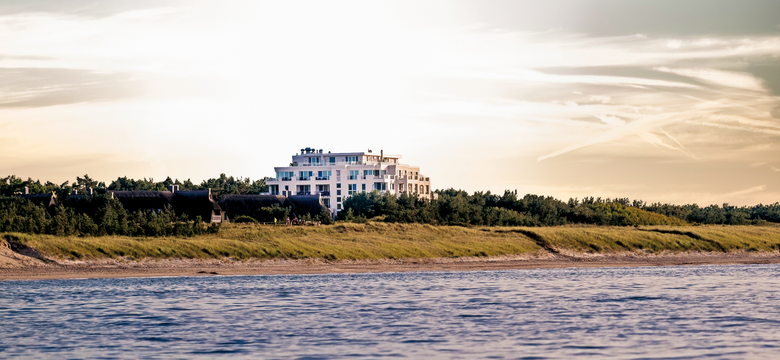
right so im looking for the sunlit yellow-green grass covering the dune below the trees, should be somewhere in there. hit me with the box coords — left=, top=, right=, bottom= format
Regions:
left=0, top=222, right=780, bottom=260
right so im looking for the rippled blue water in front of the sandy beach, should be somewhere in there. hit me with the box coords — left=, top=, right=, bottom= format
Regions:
left=0, top=265, right=780, bottom=359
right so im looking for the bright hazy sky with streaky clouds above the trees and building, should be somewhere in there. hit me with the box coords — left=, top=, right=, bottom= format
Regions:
left=0, top=0, right=780, bottom=205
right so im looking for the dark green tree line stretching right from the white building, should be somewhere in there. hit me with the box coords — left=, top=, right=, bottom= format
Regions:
left=339, top=189, right=780, bottom=226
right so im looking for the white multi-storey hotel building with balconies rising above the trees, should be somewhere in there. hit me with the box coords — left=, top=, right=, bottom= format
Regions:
left=266, top=148, right=431, bottom=215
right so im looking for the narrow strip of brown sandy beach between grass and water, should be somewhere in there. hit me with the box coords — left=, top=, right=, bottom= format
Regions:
left=0, top=251, right=780, bottom=281
